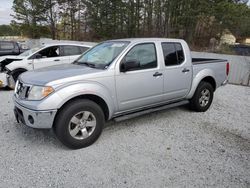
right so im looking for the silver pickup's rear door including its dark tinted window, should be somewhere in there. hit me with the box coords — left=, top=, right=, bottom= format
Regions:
left=161, top=42, right=192, bottom=101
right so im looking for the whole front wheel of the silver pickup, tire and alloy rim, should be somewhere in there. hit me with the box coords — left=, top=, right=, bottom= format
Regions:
left=53, top=99, right=105, bottom=149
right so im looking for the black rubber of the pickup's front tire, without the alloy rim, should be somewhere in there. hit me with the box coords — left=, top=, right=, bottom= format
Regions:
left=54, top=99, right=105, bottom=149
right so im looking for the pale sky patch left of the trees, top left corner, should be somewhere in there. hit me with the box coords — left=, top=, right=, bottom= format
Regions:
left=0, top=0, right=13, bottom=25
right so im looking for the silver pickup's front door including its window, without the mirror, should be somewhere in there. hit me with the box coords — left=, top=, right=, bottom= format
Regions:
left=116, top=43, right=163, bottom=111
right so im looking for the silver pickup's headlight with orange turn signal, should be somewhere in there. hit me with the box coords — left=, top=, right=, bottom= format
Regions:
left=27, top=86, right=54, bottom=100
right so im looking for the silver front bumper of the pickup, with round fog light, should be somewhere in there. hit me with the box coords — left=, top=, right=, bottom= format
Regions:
left=14, top=101, right=57, bottom=129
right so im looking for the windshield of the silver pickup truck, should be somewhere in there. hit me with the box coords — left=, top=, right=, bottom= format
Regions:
left=74, top=41, right=129, bottom=69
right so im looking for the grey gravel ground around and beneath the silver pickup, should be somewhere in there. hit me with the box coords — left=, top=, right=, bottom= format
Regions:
left=0, top=85, right=250, bottom=188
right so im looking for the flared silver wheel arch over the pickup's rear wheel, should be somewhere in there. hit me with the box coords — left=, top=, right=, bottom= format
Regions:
left=187, top=69, right=215, bottom=99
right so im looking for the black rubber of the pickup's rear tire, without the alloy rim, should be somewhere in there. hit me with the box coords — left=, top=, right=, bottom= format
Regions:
left=190, top=81, right=214, bottom=112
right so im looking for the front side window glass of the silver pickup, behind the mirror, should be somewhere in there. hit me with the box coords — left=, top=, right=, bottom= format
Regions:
left=123, top=43, right=157, bottom=70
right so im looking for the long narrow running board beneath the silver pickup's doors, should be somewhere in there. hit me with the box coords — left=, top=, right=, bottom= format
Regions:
left=114, top=100, right=189, bottom=122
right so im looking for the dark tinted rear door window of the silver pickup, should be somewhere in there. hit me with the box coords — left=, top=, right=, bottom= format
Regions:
left=161, top=43, right=185, bottom=66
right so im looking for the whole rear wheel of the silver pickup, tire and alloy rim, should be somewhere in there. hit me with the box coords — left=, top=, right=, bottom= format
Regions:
left=190, top=81, right=214, bottom=112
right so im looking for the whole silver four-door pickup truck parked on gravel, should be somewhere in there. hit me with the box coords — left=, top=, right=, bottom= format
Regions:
left=14, top=38, right=229, bottom=149
